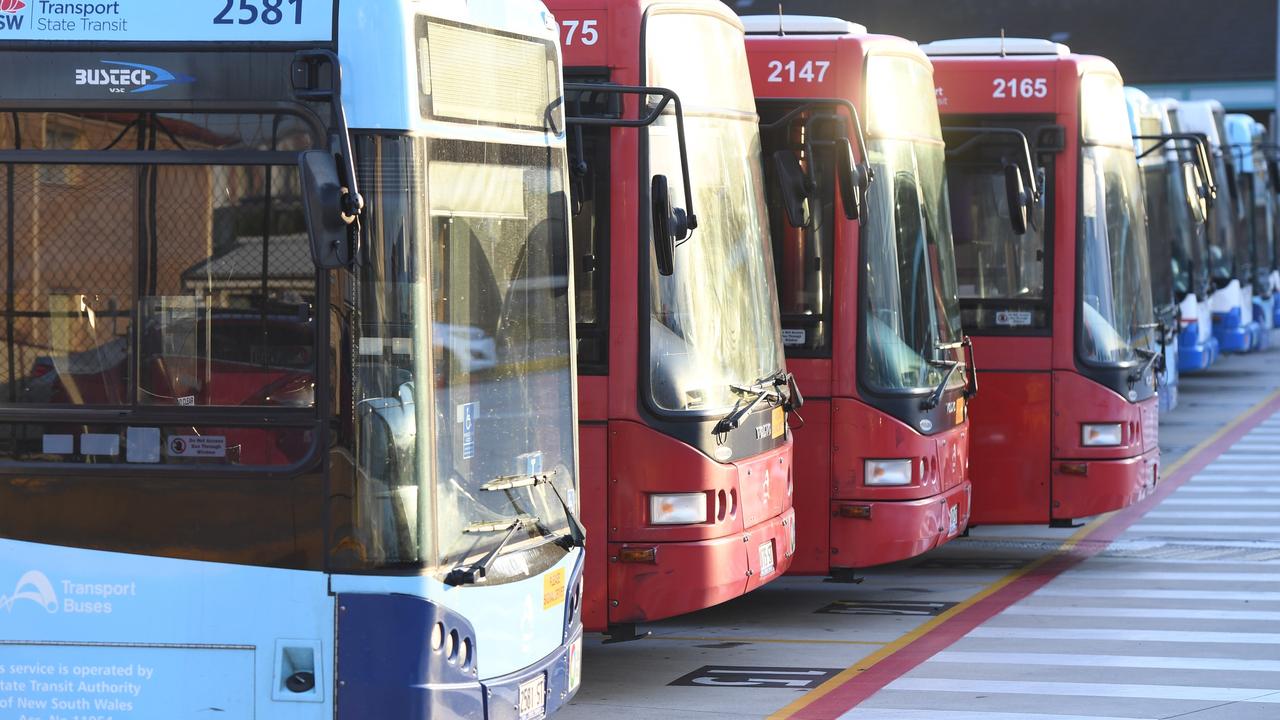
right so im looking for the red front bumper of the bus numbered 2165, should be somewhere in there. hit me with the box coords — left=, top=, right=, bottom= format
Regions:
left=1050, top=450, right=1160, bottom=520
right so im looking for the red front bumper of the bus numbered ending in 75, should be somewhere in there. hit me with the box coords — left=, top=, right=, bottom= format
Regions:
left=609, top=507, right=796, bottom=624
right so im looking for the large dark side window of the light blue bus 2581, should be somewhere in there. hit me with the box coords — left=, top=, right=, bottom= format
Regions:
left=0, top=111, right=317, bottom=450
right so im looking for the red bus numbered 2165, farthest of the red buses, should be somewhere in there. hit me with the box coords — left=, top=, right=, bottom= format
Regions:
left=923, top=38, right=1161, bottom=525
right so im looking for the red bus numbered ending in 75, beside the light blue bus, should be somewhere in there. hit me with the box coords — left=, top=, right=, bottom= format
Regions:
left=548, top=0, right=799, bottom=639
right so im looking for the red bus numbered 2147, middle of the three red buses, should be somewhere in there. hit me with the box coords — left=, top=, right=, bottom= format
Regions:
left=742, top=15, right=973, bottom=578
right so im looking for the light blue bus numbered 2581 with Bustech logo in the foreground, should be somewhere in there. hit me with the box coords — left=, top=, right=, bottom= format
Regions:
left=0, top=0, right=584, bottom=720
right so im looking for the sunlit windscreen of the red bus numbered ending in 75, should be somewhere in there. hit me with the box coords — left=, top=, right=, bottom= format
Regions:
left=643, top=10, right=785, bottom=414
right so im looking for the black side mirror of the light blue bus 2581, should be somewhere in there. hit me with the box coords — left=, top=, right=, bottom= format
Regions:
left=298, top=150, right=357, bottom=270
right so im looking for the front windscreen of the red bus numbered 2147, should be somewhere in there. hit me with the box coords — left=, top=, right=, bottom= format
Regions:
left=859, top=56, right=964, bottom=393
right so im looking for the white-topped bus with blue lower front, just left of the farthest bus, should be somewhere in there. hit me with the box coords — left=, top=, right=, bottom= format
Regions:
left=1178, top=100, right=1262, bottom=352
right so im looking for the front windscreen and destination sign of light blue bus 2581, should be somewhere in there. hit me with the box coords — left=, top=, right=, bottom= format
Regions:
left=334, top=20, right=577, bottom=582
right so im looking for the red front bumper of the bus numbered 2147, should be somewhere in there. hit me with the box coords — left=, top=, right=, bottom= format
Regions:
left=831, top=480, right=973, bottom=569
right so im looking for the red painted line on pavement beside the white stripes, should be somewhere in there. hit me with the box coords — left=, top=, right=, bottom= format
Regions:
left=790, top=395, right=1280, bottom=720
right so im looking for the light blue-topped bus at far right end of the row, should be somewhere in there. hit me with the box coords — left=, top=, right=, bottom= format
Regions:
left=1224, top=113, right=1276, bottom=347
